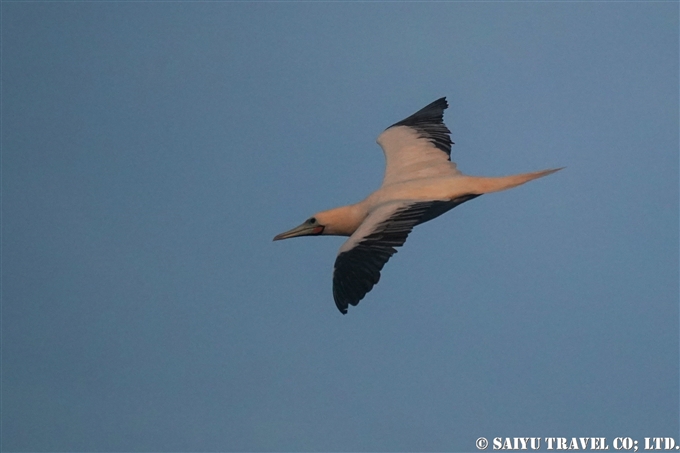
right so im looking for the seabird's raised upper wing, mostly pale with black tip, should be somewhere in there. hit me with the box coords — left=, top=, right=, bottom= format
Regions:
left=378, top=98, right=460, bottom=185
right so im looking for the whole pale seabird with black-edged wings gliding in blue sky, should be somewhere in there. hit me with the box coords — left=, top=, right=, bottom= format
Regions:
left=274, top=97, right=564, bottom=315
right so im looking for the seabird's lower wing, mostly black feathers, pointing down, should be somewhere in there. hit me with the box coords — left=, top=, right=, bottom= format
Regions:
left=333, top=195, right=478, bottom=314
